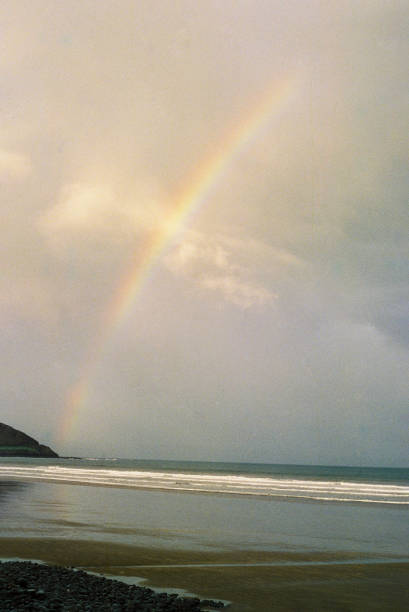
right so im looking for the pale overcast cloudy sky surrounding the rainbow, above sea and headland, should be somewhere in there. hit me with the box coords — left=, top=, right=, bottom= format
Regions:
left=0, top=0, right=409, bottom=465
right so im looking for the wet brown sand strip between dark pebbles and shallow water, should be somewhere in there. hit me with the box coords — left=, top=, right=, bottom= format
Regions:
left=0, top=538, right=409, bottom=612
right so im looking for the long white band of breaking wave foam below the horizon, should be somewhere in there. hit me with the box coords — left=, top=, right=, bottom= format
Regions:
left=0, top=465, right=409, bottom=506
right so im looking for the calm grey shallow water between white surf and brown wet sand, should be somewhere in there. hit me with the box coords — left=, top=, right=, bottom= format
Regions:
left=0, top=481, right=409, bottom=555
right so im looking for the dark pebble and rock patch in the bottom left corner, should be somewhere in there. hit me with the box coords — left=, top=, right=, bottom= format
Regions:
left=0, top=561, right=224, bottom=612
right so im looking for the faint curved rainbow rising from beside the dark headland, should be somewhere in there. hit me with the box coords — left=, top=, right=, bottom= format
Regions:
left=58, top=78, right=297, bottom=443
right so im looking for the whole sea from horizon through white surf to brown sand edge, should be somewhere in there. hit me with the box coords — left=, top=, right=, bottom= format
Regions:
left=0, top=457, right=409, bottom=556
